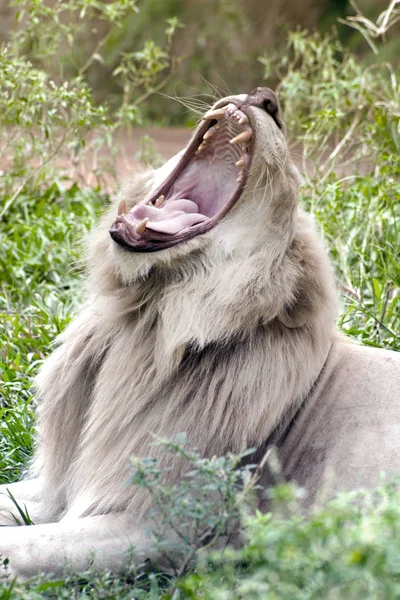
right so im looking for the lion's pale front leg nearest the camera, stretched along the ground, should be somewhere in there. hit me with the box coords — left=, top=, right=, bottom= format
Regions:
left=0, top=512, right=152, bottom=580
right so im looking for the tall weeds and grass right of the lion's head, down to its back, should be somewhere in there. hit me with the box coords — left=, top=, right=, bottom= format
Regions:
left=261, top=31, right=400, bottom=349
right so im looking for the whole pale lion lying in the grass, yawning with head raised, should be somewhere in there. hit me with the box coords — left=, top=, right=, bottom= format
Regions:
left=0, top=88, right=400, bottom=579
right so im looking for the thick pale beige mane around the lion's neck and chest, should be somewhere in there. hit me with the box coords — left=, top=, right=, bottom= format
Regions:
left=34, top=164, right=336, bottom=515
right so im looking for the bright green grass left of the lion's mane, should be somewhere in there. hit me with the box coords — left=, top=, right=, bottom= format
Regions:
left=0, top=185, right=106, bottom=483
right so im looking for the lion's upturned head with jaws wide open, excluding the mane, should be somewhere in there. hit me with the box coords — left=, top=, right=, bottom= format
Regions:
left=104, top=88, right=299, bottom=278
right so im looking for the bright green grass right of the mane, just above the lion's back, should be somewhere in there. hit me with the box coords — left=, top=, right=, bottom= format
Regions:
left=306, top=176, right=400, bottom=350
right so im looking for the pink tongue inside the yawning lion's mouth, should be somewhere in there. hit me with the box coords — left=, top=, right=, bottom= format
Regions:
left=130, top=198, right=207, bottom=235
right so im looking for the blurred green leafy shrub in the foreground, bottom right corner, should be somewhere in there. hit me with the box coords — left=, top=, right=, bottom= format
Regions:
left=177, top=482, right=400, bottom=600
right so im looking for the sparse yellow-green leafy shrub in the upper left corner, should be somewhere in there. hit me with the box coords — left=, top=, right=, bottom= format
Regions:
left=0, top=0, right=181, bottom=220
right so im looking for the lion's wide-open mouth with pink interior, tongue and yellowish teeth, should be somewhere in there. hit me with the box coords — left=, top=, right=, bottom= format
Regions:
left=110, top=102, right=254, bottom=252
